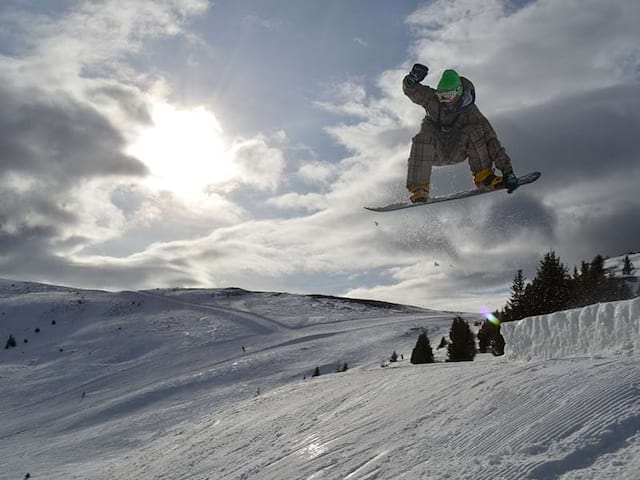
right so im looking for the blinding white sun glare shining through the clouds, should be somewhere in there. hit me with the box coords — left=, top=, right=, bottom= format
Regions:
left=128, top=103, right=235, bottom=198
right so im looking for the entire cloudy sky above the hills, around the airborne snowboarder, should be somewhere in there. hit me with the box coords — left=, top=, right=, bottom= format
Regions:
left=0, top=0, right=640, bottom=311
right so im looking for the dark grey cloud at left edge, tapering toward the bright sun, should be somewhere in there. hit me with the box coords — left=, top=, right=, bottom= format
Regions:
left=0, top=83, right=147, bottom=183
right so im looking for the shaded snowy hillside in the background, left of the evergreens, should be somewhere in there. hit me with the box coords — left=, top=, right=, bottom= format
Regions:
left=0, top=280, right=458, bottom=479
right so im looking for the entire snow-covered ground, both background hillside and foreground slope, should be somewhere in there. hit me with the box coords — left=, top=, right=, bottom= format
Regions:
left=0, top=280, right=640, bottom=480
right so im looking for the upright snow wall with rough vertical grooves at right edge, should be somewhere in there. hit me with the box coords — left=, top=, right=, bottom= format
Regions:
left=502, top=298, right=640, bottom=360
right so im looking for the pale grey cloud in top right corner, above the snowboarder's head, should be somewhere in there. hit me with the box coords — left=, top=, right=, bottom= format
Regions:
left=407, top=0, right=640, bottom=112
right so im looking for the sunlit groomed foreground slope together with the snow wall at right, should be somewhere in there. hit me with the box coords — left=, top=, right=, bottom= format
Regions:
left=102, top=300, right=640, bottom=480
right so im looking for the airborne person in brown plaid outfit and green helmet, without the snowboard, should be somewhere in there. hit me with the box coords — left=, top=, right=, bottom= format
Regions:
left=402, top=63, right=519, bottom=203
